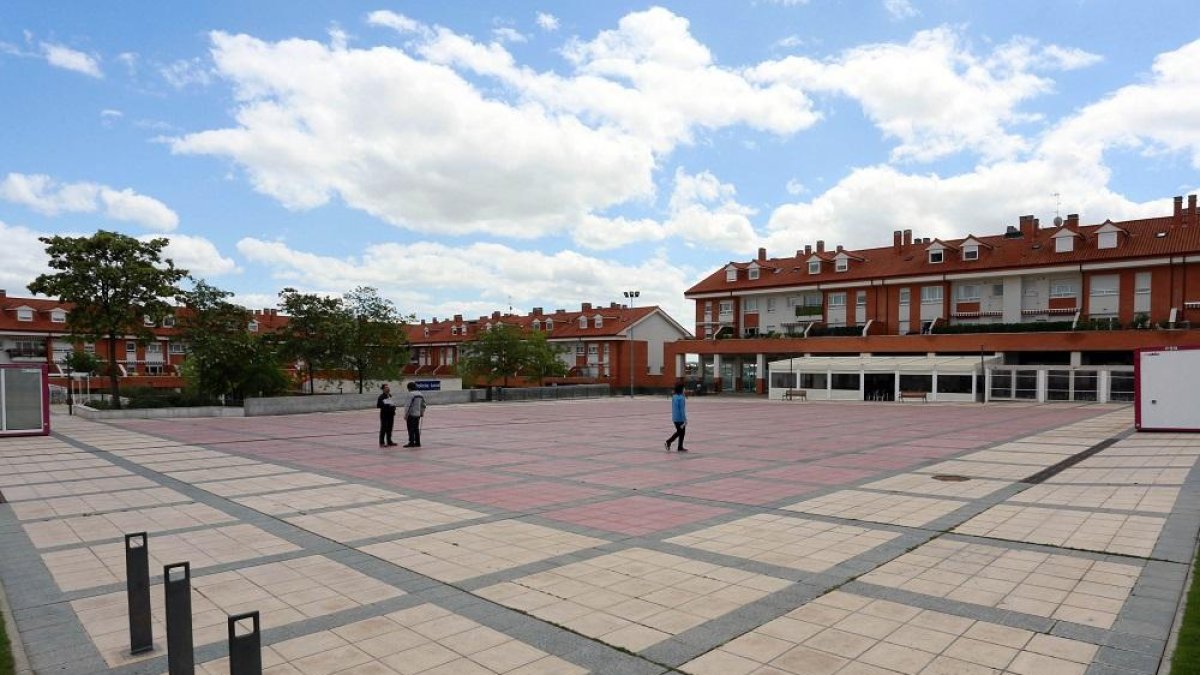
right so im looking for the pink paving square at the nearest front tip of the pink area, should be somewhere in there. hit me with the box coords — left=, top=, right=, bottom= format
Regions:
left=541, top=496, right=730, bottom=536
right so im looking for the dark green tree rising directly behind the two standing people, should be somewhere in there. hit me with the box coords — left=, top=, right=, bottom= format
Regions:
left=342, top=286, right=413, bottom=394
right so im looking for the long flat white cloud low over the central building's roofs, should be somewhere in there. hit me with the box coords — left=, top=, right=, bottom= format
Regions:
left=238, top=238, right=697, bottom=324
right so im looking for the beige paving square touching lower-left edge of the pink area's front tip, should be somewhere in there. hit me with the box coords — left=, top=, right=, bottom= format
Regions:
left=352, top=520, right=605, bottom=581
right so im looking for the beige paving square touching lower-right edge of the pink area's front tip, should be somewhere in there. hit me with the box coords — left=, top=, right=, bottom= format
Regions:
left=667, top=513, right=900, bottom=572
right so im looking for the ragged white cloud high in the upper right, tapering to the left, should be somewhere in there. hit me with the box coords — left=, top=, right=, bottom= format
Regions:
left=752, top=26, right=1087, bottom=162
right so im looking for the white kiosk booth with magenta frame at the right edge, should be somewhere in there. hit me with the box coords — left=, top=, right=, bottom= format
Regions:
left=1133, top=346, right=1200, bottom=431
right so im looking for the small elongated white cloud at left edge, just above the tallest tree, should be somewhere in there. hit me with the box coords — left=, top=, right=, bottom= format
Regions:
left=0, top=173, right=179, bottom=231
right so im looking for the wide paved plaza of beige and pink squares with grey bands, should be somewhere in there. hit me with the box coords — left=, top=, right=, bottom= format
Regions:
left=0, top=396, right=1200, bottom=675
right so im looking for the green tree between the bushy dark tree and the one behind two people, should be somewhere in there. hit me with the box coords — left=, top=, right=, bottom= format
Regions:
left=278, top=288, right=353, bottom=394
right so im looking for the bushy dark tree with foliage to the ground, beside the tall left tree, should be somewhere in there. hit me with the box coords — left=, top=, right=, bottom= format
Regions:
left=179, top=280, right=288, bottom=399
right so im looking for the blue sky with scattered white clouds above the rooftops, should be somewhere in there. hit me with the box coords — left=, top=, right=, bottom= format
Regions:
left=0, top=0, right=1200, bottom=325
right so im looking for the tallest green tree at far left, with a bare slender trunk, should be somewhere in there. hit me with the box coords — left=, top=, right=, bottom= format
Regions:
left=29, top=229, right=187, bottom=408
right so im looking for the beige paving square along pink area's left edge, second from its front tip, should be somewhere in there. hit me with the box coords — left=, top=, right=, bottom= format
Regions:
left=284, top=500, right=486, bottom=544
